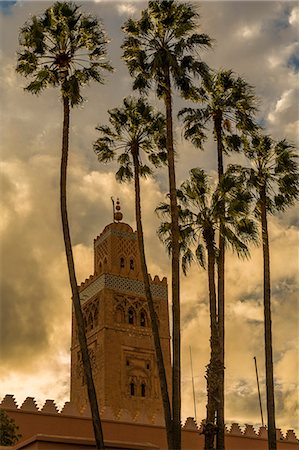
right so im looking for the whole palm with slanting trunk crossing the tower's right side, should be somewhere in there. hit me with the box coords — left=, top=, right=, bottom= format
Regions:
left=94, top=98, right=172, bottom=449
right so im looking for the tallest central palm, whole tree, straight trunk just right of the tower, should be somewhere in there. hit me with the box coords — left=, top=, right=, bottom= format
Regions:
left=122, top=0, right=211, bottom=450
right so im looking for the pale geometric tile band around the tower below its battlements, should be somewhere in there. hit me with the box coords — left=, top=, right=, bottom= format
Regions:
left=80, top=274, right=167, bottom=304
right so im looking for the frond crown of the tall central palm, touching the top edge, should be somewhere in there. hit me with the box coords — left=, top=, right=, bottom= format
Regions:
left=122, top=0, right=211, bottom=98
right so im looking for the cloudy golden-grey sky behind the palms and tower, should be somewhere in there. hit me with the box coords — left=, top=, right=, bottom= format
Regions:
left=0, top=1, right=299, bottom=432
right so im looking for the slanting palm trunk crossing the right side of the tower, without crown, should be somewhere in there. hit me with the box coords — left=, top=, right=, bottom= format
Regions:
left=132, top=149, right=174, bottom=450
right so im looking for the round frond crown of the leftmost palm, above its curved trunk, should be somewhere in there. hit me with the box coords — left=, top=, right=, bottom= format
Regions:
left=17, top=2, right=112, bottom=105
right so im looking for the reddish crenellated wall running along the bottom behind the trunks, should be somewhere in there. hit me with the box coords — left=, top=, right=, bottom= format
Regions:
left=0, top=395, right=299, bottom=450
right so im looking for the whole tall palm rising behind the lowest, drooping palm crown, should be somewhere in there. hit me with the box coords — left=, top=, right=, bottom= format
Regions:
left=179, top=70, right=256, bottom=450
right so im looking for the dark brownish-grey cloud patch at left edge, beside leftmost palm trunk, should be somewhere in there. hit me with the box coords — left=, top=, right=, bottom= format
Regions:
left=0, top=224, right=51, bottom=369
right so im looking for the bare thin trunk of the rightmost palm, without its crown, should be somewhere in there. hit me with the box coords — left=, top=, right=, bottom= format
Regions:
left=260, top=186, right=277, bottom=450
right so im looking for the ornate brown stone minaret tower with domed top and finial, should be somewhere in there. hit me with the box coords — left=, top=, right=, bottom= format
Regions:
left=71, top=202, right=171, bottom=421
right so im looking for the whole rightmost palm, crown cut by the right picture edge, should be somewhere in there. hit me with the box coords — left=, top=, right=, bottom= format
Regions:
left=231, top=135, right=299, bottom=450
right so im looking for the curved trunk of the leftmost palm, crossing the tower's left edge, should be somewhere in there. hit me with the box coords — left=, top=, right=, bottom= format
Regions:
left=60, top=96, right=105, bottom=450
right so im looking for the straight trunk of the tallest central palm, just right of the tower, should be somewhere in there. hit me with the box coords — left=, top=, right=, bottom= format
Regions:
left=164, top=68, right=181, bottom=450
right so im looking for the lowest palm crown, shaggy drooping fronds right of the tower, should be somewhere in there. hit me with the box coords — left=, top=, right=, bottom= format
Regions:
left=157, top=168, right=257, bottom=273
